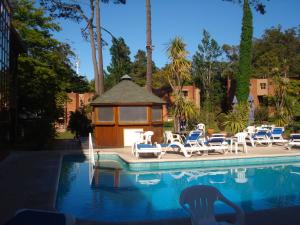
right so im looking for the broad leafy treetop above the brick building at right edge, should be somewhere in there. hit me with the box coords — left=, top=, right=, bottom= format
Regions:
left=253, top=27, right=300, bottom=78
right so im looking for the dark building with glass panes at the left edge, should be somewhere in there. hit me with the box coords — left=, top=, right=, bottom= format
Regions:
left=0, top=0, right=26, bottom=142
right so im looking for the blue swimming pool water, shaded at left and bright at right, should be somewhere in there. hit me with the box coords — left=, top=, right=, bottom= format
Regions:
left=56, top=156, right=300, bottom=222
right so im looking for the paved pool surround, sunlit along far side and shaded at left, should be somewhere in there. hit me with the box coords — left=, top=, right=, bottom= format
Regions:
left=0, top=141, right=300, bottom=225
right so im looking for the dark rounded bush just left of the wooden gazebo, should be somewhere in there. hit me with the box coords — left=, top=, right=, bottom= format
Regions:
left=68, top=107, right=92, bottom=138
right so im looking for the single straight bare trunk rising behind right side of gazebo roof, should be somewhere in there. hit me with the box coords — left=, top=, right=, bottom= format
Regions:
left=146, top=0, right=152, bottom=92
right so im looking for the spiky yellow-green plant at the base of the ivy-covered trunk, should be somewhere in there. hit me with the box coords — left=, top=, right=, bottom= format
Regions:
left=218, top=103, right=249, bottom=134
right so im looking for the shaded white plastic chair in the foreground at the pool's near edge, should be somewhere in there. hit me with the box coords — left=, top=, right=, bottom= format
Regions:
left=179, top=185, right=244, bottom=225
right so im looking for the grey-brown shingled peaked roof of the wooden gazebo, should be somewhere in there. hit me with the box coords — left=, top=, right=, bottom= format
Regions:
left=91, top=75, right=165, bottom=105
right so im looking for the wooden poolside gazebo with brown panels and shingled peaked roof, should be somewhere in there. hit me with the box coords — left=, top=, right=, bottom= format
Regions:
left=91, top=75, right=165, bottom=147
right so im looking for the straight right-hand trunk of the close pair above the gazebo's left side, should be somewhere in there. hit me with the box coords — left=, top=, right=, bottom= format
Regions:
left=96, top=0, right=104, bottom=95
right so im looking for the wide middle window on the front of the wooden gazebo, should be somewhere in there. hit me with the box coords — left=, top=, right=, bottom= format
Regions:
left=119, top=106, right=148, bottom=123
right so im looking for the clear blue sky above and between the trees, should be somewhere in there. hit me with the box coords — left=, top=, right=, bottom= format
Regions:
left=54, top=0, right=300, bottom=80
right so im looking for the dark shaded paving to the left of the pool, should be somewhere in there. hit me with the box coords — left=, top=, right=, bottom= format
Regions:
left=0, top=152, right=61, bottom=224
